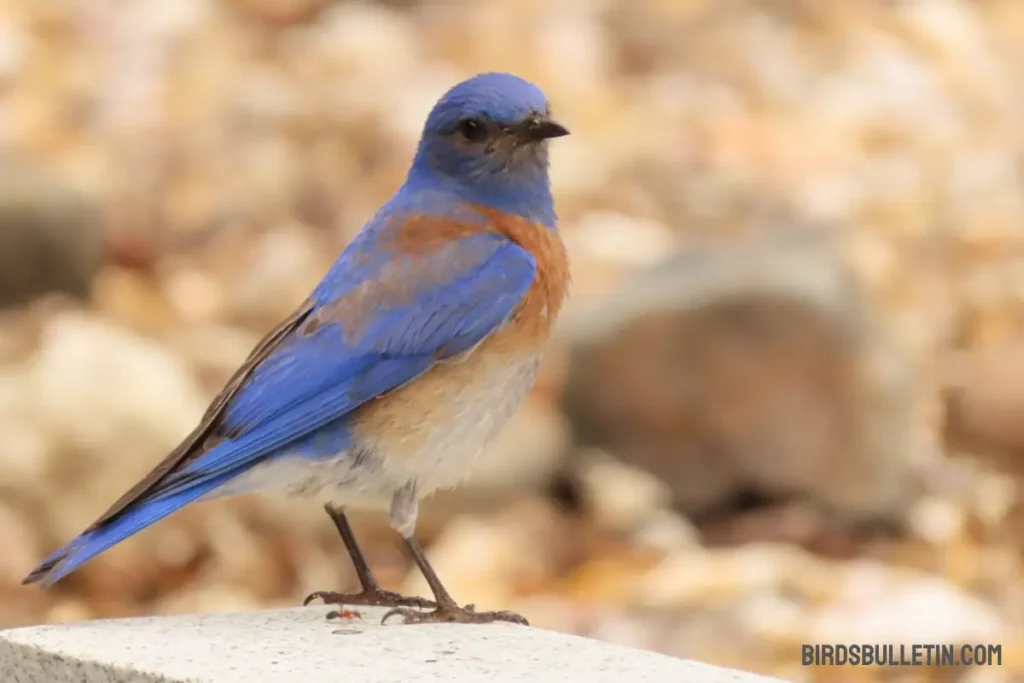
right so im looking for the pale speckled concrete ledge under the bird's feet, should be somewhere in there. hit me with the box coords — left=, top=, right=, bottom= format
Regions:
left=0, top=606, right=774, bottom=683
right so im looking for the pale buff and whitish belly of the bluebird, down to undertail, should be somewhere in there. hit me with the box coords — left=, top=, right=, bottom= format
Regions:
left=209, top=354, right=539, bottom=509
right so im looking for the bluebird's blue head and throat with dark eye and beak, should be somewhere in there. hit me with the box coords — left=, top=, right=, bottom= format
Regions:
left=410, top=73, right=568, bottom=227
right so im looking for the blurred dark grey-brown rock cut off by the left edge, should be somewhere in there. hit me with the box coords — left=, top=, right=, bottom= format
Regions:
left=0, top=159, right=102, bottom=306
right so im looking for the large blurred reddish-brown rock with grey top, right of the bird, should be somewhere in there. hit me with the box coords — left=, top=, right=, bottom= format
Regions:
left=566, top=231, right=914, bottom=519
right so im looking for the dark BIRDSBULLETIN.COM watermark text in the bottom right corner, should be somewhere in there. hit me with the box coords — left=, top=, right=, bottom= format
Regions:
left=800, top=644, right=1002, bottom=667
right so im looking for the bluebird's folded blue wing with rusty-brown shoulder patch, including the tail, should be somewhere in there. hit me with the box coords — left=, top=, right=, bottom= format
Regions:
left=24, top=227, right=537, bottom=585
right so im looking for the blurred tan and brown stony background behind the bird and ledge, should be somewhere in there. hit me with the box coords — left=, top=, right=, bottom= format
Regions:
left=0, top=0, right=1024, bottom=681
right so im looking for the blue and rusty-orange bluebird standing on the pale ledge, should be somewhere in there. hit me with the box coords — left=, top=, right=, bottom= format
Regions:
left=23, top=72, right=570, bottom=624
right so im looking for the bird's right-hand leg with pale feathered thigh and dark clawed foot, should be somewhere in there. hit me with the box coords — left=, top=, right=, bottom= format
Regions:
left=381, top=486, right=528, bottom=626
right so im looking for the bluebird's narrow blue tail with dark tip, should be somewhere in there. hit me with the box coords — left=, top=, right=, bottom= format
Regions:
left=22, top=470, right=238, bottom=586
